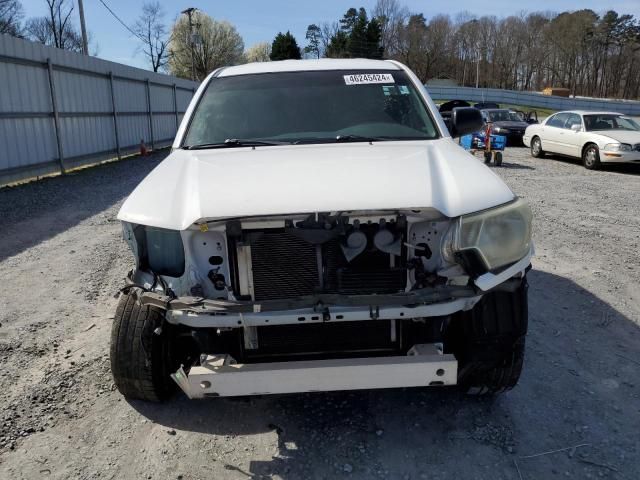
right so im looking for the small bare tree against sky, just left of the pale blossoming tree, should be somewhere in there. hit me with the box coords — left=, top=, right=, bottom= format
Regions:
left=133, top=1, right=169, bottom=72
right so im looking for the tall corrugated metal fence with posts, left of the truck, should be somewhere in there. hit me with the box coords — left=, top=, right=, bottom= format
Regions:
left=0, top=35, right=198, bottom=185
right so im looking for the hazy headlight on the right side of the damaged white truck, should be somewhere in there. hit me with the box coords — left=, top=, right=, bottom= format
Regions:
left=443, top=199, right=532, bottom=270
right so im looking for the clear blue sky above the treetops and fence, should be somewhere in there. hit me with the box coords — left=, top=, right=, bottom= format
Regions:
left=21, top=0, right=640, bottom=68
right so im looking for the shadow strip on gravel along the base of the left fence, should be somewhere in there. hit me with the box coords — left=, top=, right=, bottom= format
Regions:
left=0, top=150, right=168, bottom=260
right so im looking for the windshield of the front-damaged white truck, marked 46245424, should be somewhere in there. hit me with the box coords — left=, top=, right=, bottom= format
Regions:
left=183, top=70, right=438, bottom=148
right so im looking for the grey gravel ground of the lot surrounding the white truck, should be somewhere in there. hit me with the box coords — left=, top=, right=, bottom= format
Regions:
left=0, top=148, right=640, bottom=480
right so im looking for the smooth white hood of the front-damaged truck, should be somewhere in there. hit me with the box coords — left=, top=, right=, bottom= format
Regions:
left=118, top=138, right=514, bottom=230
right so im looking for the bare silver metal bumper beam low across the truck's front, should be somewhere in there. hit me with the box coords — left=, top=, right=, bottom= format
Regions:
left=171, top=344, right=458, bottom=399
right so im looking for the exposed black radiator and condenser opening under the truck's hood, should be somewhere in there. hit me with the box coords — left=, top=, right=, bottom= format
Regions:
left=222, top=214, right=449, bottom=301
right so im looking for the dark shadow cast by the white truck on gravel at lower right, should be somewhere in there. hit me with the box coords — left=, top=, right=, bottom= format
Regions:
left=131, top=271, right=640, bottom=480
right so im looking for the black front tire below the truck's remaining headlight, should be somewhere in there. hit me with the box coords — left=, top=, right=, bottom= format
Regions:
left=452, top=279, right=528, bottom=395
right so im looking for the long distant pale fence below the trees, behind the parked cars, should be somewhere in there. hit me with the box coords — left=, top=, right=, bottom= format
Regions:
left=427, top=85, right=640, bottom=115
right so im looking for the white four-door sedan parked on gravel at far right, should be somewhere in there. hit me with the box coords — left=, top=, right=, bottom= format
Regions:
left=522, top=110, right=640, bottom=169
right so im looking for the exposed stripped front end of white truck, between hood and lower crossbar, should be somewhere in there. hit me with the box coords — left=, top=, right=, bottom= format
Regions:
left=124, top=210, right=478, bottom=327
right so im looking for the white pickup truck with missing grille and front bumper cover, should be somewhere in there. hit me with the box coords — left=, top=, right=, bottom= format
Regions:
left=111, top=59, right=533, bottom=401
